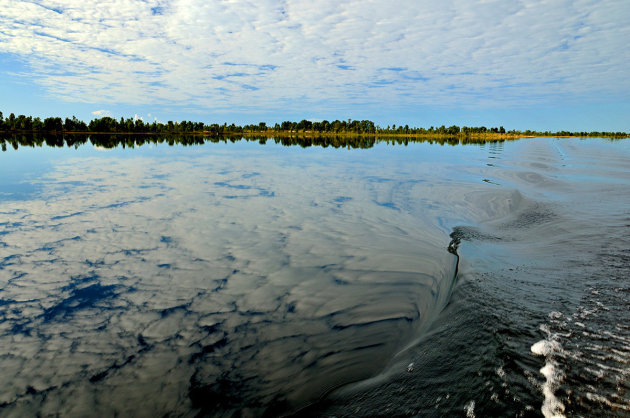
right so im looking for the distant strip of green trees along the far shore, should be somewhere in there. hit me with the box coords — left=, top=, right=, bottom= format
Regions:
left=0, top=112, right=629, bottom=138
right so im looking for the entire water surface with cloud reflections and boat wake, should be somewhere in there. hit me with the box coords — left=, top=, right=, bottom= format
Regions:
left=0, top=138, right=630, bottom=417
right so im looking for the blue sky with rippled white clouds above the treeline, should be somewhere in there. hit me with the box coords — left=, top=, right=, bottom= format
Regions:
left=0, top=0, right=630, bottom=131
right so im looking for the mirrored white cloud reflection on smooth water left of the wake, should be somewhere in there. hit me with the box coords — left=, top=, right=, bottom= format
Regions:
left=0, top=145, right=462, bottom=416
